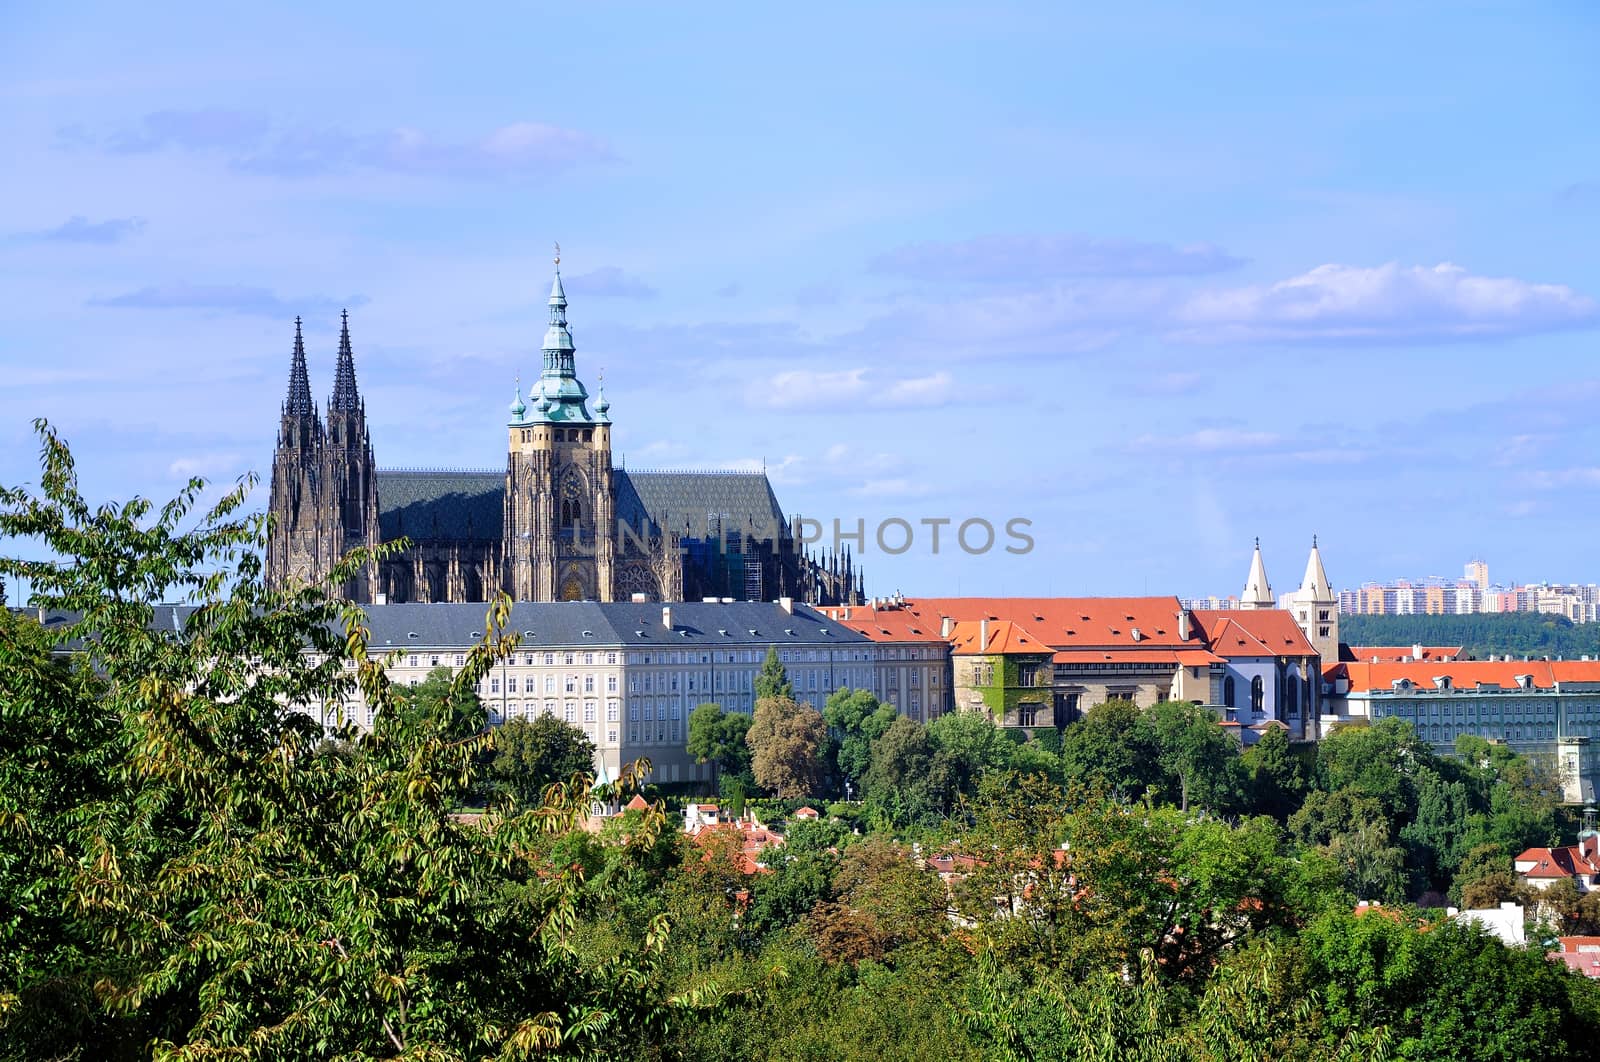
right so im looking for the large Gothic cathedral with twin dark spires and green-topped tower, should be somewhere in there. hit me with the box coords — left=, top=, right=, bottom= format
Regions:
left=267, top=258, right=864, bottom=605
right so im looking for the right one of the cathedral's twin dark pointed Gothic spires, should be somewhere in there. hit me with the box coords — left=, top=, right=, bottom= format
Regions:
left=318, top=310, right=378, bottom=601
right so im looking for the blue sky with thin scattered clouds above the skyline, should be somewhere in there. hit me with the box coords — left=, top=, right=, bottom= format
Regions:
left=0, top=0, right=1600, bottom=597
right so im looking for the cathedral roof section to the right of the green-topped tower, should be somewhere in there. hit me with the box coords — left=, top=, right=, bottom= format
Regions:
left=616, top=469, right=786, bottom=539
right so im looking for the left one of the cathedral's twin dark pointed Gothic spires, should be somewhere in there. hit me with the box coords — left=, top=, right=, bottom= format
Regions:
left=267, top=317, right=325, bottom=587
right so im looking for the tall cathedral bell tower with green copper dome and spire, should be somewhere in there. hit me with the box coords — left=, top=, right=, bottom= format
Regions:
left=502, top=246, right=616, bottom=601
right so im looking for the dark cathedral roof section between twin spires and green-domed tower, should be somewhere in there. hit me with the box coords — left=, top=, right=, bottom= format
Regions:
left=378, top=472, right=506, bottom=542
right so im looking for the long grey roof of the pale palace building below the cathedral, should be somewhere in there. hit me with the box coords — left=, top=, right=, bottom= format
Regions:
left=362, top=601, right=870, bottom=649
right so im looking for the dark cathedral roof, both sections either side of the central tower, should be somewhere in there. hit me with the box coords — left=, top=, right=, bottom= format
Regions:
left=378, top=469, right=787, bottom=541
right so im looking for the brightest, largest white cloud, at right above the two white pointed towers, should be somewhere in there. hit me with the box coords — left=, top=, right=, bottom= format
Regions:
left=1173, top=262, right=1597, bottom=342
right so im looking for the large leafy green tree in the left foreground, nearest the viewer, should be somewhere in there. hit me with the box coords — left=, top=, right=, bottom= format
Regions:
left=0, top=424, right=717, bottom=1057
